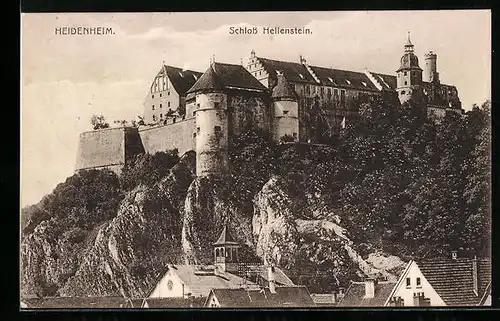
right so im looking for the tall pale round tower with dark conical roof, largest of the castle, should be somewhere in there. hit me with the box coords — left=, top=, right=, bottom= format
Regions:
left=188, top=61, right=228, bottom=176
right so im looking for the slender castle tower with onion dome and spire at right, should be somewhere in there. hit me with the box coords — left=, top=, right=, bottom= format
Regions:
left=396, top=32, right=422, bottom=103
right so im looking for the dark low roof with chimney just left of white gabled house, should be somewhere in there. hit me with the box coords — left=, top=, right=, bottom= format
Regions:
left=338, top=282, right=396, bottom=307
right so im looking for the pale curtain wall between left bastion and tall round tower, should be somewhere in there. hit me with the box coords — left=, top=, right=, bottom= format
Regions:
left=139, top=118, right=196, bottom=155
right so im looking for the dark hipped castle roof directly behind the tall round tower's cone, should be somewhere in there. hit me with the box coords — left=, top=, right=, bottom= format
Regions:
left=187, top=62, right=267, bottom=93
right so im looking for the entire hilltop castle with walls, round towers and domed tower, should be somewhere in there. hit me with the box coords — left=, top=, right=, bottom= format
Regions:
left=76, top=34, right=463, bottom=176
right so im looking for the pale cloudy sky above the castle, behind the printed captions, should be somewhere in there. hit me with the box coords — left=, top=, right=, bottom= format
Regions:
left=21, top=10, right=491, bottom=206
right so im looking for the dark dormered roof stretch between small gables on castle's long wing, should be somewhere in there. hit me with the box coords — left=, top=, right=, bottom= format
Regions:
left=309, top=66, right=378, bottom=91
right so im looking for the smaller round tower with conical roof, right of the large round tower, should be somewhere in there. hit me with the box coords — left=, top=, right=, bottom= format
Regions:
left=271, top=72, right=299, bottom=143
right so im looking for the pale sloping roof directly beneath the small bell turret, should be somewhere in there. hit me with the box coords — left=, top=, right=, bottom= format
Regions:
left=171, top=265, right=258, bottom=297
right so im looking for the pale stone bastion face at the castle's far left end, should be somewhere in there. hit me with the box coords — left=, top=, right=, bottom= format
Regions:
left=75, top=127, right=132, bottom=170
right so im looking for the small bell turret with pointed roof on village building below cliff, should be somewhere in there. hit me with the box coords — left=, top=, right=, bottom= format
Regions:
left=213, top=222, right=240, bottom=273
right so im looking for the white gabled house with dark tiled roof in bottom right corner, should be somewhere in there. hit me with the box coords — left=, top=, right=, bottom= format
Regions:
left=386, top=253, right=491, bottom=306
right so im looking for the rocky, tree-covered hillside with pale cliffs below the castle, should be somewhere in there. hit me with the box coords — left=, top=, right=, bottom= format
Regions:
left=21, top=98, right=491, bottom=297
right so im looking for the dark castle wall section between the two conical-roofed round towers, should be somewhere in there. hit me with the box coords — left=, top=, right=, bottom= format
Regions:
left=228, top=94, right=271, bottom=135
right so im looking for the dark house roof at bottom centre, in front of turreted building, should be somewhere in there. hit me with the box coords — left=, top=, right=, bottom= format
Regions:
left=211, top=286, right=315, bottom=308
